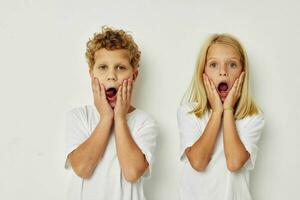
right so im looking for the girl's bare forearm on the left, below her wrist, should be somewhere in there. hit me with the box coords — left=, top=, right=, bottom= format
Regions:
left=186, top=112, right=222, bottom=171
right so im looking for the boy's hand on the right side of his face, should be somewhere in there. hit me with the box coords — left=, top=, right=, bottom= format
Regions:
left=114, top=78, right=133, bottom=119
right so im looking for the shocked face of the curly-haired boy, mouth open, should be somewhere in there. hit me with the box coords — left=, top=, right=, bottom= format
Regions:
left=90, top=48, right=138, bottom=108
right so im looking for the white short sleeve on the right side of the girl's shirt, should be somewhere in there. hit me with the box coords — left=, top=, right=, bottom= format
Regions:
left=238, top=114, right=265, bottom=170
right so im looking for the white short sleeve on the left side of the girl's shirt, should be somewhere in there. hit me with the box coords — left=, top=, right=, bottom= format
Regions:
left=177, top=105, right=203, bottom=161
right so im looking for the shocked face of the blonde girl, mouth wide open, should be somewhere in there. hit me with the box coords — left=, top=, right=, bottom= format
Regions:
left=204, top=44, right=243, bottom=102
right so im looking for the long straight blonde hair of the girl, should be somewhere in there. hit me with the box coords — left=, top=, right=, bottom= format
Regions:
left=182, top=34, right=261, bottom=119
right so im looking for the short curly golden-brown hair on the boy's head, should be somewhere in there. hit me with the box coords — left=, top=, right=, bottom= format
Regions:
left=85, top=26, right=141, bottom=70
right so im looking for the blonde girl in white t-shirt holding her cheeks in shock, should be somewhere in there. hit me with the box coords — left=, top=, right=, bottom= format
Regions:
left=177, top=34, right=264, bottom=200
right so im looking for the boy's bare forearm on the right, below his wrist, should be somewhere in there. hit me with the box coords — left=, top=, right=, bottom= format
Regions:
left=115, top=118, right=148, bottom=182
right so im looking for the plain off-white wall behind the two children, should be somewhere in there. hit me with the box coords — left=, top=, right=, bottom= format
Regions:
left=0, top=0, right=300, bottom=200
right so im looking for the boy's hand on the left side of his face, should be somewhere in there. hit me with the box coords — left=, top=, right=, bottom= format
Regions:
left=92, top=76, right=114, bottom=119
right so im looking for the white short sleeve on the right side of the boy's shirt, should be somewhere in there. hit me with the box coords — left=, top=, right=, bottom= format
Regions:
left=133, top=119, right=158, bottom=178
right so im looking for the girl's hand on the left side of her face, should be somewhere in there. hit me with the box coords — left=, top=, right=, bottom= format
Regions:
left=203, top=74, right=223, bottom=113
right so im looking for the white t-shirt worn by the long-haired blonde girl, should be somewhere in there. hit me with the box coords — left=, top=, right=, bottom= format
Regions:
left=177, top=103, right=264, bottom=200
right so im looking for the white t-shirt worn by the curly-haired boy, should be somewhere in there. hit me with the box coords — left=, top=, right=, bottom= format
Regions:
left=65, top=105, right=158, bottom=200
